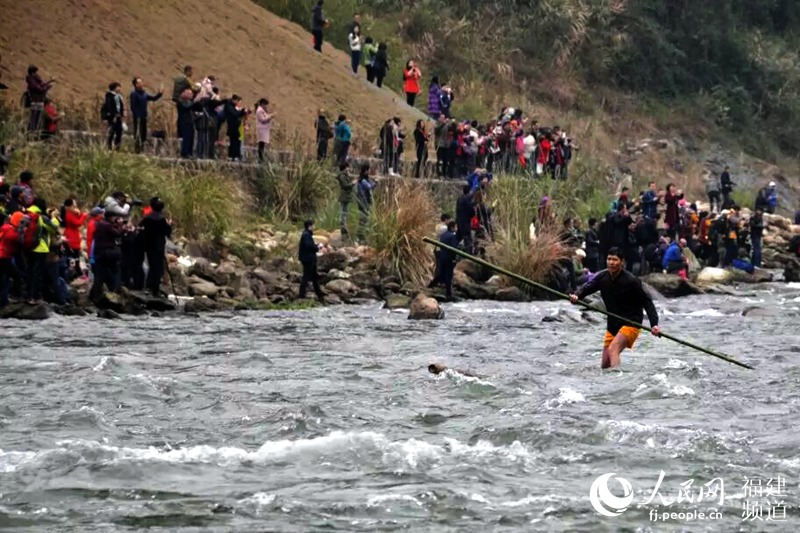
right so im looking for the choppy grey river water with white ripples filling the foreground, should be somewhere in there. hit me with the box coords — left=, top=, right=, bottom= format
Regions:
left=0, top=285, right=800, bottom=532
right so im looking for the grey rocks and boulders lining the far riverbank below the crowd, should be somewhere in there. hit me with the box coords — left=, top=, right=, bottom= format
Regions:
left=0, top=215, right=800, bottom=320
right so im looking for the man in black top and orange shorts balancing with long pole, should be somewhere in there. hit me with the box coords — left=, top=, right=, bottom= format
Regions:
left=570, top=247, right=661, bottom=368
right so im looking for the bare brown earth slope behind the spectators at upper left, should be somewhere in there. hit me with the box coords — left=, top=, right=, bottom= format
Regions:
left=0, top=0, right=419, bottom=144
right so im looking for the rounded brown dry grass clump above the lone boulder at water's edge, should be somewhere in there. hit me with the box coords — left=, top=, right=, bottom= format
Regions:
left=369, top=180, right=438, bottom=286
